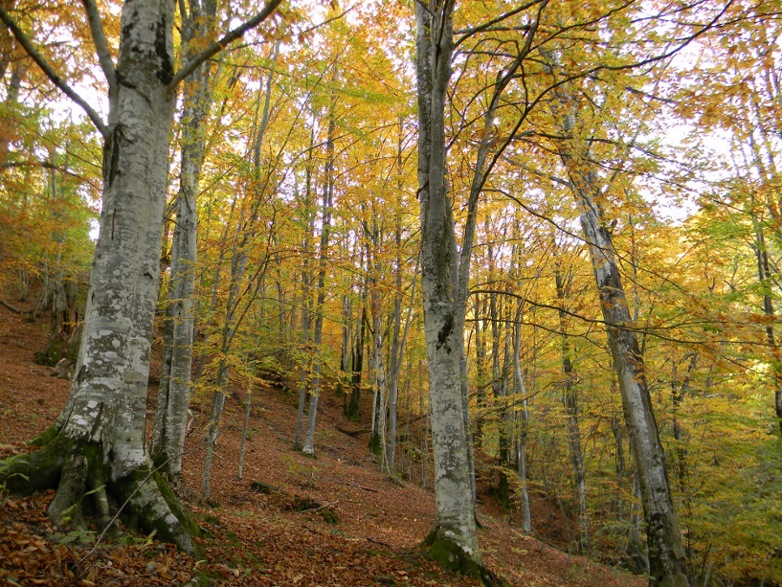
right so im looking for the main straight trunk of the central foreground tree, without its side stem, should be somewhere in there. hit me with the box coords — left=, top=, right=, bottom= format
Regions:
left=415, top=0, right=480, bottom=562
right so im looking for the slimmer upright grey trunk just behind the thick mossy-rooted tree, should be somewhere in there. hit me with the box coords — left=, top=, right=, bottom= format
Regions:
left=151, top=0, right=217, bottom=484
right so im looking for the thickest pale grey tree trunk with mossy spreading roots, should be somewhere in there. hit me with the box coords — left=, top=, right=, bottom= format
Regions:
left=0, top=0, right=196, bottom=552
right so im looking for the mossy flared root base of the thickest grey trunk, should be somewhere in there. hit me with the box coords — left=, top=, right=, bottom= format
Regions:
left=0, top=429, right=199, bottom=555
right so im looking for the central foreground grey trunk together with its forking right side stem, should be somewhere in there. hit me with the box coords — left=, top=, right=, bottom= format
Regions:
left=415, top=0, right=546, bottom=561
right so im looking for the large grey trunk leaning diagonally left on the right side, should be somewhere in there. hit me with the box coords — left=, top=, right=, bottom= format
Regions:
left=554, top=104, right=689, bottom=587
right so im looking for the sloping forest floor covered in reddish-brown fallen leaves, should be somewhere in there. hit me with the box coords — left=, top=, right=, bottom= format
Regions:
left=0, top=306, right=646, bottom=587
